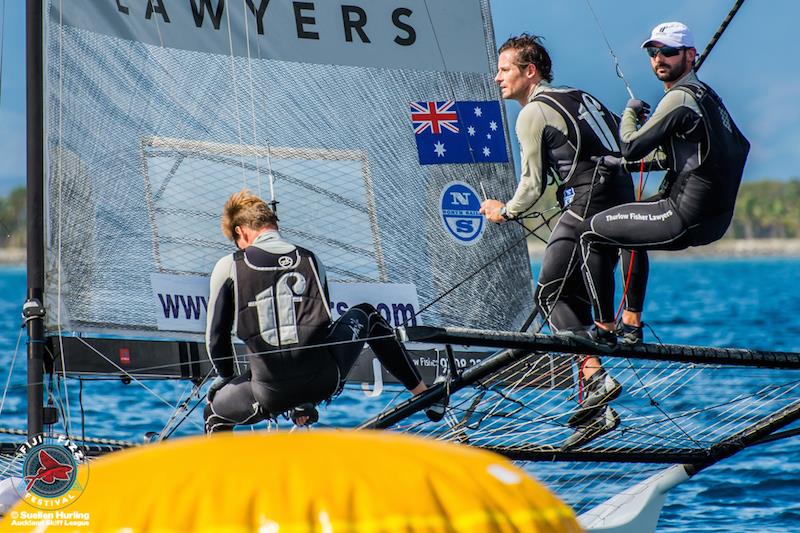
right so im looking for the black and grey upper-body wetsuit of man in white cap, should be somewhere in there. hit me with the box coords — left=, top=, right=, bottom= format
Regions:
left=620, top=72, right=749, bottom=221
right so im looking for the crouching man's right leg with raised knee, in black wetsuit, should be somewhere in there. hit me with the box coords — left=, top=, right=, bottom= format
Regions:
left=327, top=303, right=424, bottom=393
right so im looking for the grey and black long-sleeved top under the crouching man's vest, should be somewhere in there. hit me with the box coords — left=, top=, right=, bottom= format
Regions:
left=206, top=230, right=327, bottom=377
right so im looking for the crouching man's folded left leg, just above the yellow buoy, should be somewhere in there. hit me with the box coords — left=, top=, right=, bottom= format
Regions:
left=203, top=372, right=265, bottom=433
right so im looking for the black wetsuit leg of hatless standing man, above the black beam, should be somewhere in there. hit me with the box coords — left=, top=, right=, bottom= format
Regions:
left=534, top=211, right=592, bottom=333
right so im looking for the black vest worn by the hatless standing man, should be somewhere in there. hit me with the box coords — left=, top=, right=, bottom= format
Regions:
left=533, top=88, right=633, bottom=215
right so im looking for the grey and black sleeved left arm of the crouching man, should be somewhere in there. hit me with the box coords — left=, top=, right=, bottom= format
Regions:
left=206, top=255, right=236, bottom=378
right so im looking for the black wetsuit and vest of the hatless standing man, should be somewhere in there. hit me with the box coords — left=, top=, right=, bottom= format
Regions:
left=508, top=84, right=648, bottom=332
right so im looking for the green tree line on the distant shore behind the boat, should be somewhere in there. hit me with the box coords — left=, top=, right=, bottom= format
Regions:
left=0, top=178, right=800, bottom=248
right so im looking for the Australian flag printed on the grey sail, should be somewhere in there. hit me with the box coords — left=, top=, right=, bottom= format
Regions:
left=411, top=100, right=508, bottom=165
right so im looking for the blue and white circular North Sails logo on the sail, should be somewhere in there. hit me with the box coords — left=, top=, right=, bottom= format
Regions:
left=439, top=181, right=486, bottom=245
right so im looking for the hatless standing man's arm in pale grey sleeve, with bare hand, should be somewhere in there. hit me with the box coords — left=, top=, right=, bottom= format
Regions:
left=481, top=102, right=547, bottom=222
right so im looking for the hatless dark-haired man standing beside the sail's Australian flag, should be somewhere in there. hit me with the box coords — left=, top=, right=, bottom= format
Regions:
left=480, top=34, right=648, bottom=448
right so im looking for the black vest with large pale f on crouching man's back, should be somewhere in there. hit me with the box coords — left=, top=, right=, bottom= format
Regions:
left=234, top=246, right=331, bottom=362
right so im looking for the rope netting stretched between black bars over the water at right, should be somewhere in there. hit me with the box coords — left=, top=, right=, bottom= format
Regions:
left=376, top=354, right=800, bottom=514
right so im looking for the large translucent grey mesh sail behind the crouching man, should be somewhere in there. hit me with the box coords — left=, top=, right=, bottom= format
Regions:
left=45, top=0, right=532, bottom=338
